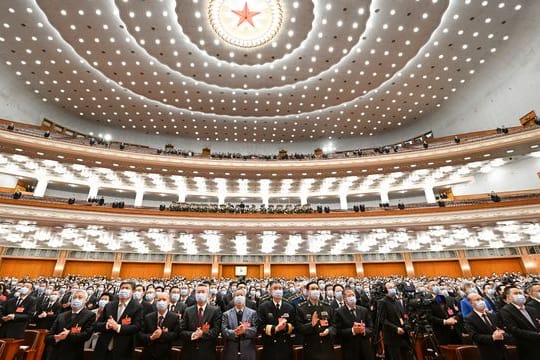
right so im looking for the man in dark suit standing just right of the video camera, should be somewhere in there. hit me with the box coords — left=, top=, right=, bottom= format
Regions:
left=427, top=281, right=462, bottom=345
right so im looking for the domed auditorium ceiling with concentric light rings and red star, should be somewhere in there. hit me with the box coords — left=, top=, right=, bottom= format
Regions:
left=0, top=0, right=532, bottom=143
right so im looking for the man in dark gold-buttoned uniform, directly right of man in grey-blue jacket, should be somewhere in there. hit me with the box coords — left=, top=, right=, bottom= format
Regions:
left=258, top=280, right=296, bottom=360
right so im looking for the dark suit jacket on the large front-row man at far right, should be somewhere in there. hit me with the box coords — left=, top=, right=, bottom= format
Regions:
left=500, top=304, right=540, bottom=359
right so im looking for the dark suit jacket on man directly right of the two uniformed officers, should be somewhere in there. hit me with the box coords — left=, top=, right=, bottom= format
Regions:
left=335, top=305, right=375, bottom=360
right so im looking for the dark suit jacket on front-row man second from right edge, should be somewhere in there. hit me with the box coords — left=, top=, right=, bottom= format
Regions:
left=464, top=311, right=510, bottom=360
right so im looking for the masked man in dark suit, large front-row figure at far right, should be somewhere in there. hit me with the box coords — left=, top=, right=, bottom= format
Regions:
left=500, top=285, right=540, bottom=360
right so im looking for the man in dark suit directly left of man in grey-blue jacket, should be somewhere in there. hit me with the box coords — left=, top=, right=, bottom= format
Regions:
left=180, top=284, right=221, bottom=360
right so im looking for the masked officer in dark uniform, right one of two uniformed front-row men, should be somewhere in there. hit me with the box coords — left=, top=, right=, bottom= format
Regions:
left=296, top=281, right=336, bottom=360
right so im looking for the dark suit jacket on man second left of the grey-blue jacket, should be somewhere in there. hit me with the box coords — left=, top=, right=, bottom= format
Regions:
left=138, top=311, right=180, bottom=359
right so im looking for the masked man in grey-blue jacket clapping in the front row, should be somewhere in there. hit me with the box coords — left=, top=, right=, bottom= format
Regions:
left=221, top=290, right=257, bottom=360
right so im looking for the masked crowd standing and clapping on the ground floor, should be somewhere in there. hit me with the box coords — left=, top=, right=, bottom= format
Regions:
left=0, top=274, right=540, bottom=360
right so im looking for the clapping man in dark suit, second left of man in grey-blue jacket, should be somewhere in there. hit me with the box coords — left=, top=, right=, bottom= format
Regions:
left=139, top=293, right=180, bottom=360
